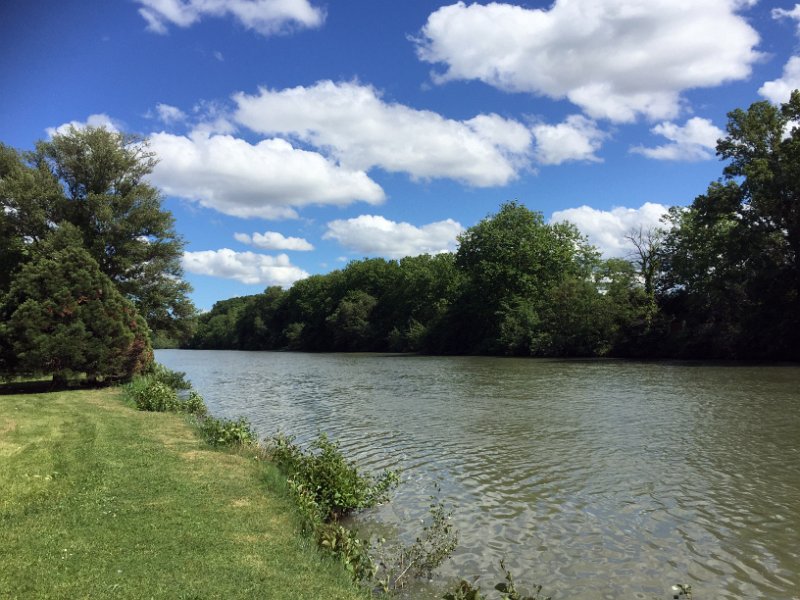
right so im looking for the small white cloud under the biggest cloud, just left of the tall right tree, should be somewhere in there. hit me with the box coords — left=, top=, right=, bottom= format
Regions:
left=631, top=117, right=725, bottom=161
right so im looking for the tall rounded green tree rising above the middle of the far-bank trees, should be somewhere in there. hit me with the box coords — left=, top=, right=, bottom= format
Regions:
left=454, top=202, right=598, bottom=354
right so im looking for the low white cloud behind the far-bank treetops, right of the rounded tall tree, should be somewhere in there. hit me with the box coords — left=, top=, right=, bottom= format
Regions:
left=550, top=202, right=668, bottom=258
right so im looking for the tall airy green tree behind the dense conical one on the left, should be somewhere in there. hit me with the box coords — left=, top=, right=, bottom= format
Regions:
left=0, top=127, right=194, bottom=337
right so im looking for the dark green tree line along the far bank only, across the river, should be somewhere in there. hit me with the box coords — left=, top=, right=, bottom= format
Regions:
left=186, top=92, right=800, bottom=360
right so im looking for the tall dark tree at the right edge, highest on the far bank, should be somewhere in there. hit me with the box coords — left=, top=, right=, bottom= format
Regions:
left=661, top=91, right=800, bottom=359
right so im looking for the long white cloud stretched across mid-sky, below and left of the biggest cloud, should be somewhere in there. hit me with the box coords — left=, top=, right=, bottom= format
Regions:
left=234, top=81, right=531, bottom=187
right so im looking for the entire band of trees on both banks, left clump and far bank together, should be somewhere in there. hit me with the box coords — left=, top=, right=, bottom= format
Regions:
left=0, top=91, right=800, bottom=380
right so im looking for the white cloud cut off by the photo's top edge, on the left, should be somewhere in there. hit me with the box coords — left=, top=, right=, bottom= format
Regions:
left=136, top=0, right=325, bottom=35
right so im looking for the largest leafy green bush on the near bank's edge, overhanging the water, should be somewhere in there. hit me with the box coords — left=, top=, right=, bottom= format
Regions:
left=268, top=433, right=399, bottom=522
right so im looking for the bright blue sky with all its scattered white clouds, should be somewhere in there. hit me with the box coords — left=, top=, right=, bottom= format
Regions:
left=0, top=0, right=800, bottom=309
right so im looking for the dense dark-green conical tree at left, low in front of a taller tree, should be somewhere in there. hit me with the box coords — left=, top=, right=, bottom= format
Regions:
left=0, top=230, right=153, bottom=381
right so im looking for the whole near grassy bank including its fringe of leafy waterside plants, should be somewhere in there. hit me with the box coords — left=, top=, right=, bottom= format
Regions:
left=0, top=365, right=564, bottom=600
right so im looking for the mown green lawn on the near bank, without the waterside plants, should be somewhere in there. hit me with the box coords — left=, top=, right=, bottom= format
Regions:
left=0, top=389, right=365, bottom=600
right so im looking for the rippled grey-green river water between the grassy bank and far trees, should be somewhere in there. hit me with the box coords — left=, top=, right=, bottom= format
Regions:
left=156, top=350, right=800, bottom=600
